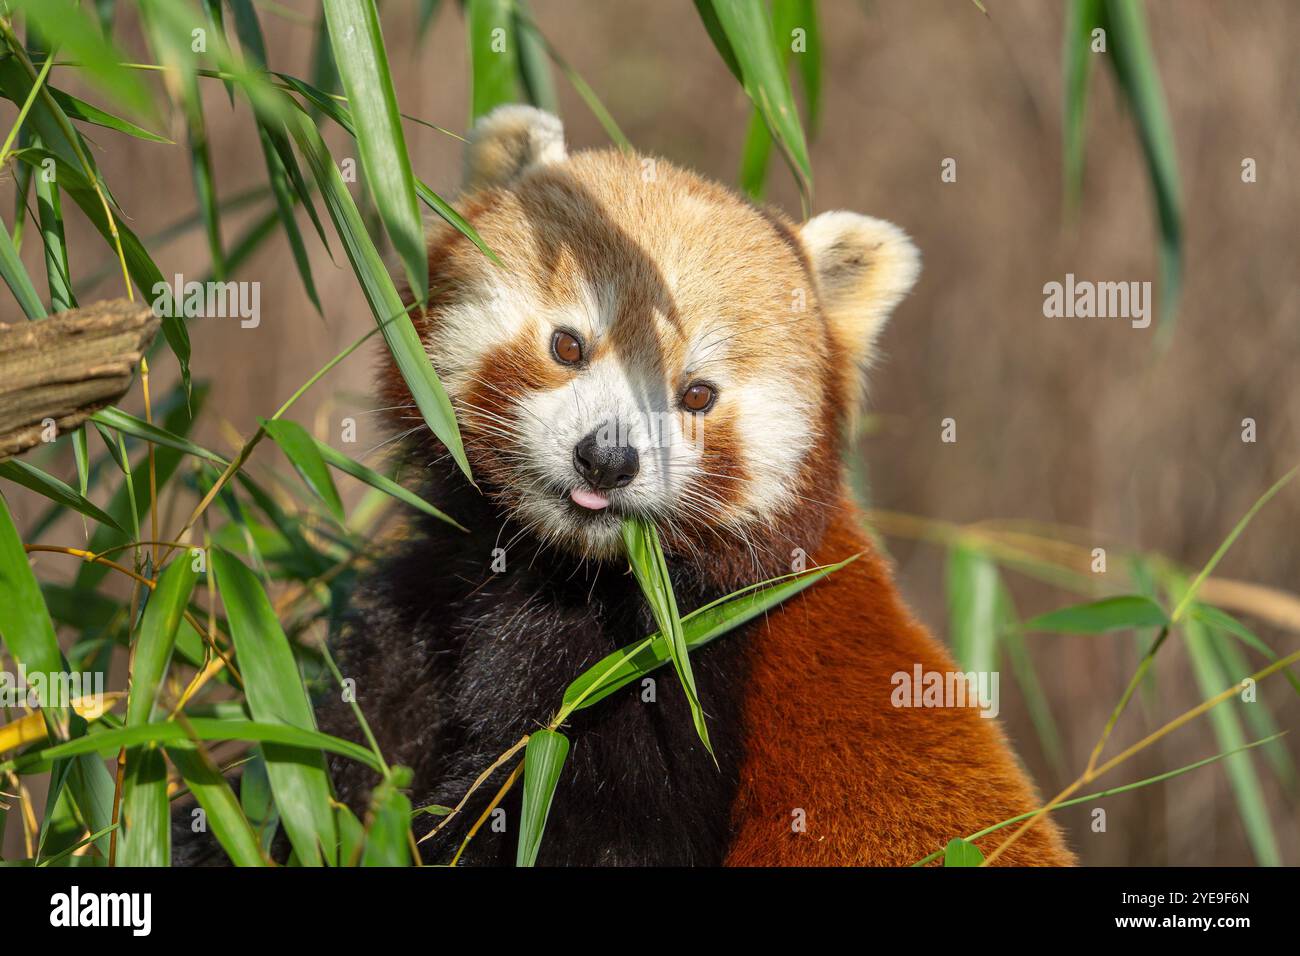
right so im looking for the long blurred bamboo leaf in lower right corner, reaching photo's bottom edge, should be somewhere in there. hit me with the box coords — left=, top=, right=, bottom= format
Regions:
left=1183, top=619, right=1282, bottom=866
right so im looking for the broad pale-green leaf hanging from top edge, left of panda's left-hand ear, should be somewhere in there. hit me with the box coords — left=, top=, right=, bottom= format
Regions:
left=325, top=0, right=429, bottom=302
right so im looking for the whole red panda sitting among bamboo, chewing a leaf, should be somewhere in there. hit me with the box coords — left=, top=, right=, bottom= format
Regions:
left=309, top=107, right=1073, bottom=866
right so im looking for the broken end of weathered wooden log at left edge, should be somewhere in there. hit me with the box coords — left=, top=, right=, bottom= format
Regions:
left=0, top=299, right=159, bottom=459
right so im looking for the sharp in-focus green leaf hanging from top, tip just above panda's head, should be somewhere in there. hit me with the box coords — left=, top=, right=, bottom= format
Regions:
left=696, top=0, right=813, bottom=212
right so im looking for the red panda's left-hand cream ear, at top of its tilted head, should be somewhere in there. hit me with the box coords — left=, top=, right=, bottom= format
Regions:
left=465, top=104, right=568, bottom=190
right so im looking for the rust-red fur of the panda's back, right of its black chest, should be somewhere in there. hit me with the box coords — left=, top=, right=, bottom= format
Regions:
left=727, top=502, right=1074, bottom=866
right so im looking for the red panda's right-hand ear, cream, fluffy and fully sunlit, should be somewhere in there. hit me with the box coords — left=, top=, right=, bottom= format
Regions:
left=800, top=212, right=920, bottom=400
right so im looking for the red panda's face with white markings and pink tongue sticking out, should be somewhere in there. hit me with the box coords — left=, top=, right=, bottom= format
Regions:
left=387, top=108, right=925, bottom=558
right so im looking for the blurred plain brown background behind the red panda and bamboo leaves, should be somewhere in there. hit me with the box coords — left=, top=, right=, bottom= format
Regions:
left=0, top=0, right=1300, bottom=865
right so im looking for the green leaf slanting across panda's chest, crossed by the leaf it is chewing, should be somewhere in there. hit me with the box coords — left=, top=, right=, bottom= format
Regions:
left=562, top=555, right=858, bottom=714
